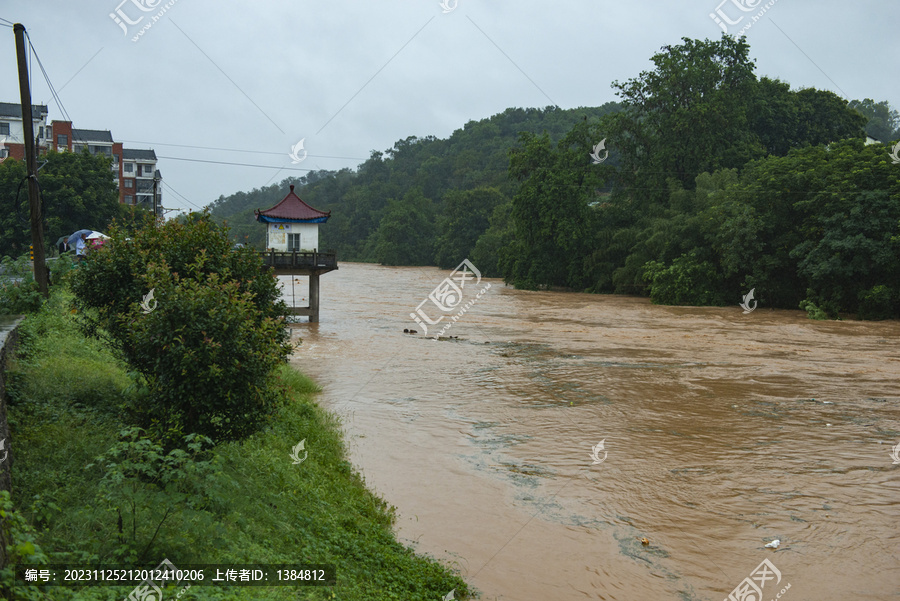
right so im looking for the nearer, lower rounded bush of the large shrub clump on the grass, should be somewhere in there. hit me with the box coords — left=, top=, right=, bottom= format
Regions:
left=119, top=270, right=292, bottom=440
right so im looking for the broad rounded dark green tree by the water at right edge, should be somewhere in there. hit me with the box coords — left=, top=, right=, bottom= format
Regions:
left=706, top=139, right=900, bottom=315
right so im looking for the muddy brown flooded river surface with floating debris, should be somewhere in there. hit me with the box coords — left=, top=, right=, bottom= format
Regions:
left=283, top=263, right=900, bottom=601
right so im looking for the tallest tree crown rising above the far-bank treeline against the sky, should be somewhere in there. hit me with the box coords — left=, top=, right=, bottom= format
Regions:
left=608, top=36, right=765, bottom=201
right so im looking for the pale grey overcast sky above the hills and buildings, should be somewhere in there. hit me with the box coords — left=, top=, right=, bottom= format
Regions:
left=0, top=0, right=900, bottom=216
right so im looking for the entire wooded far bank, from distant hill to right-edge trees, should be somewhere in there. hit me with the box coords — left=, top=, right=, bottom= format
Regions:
left=212, top=36, right=900, bottom=318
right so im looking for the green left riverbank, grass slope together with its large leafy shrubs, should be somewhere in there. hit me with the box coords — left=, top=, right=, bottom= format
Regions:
left=0, top=216, right=469, bottom=601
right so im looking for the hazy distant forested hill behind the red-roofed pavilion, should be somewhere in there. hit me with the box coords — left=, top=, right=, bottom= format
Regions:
left=210, top=102, right=620, bottom=266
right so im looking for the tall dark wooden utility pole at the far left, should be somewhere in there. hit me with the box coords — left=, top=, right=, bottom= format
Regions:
left=13, top=23, right=49, bottom=298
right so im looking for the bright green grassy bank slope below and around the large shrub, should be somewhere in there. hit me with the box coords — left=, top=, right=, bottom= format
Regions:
left=8, top=290, right=468, bottom=601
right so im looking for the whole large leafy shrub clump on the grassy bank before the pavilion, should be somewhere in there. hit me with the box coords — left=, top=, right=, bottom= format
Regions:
left=72, top=214, right=291, bottom=440
